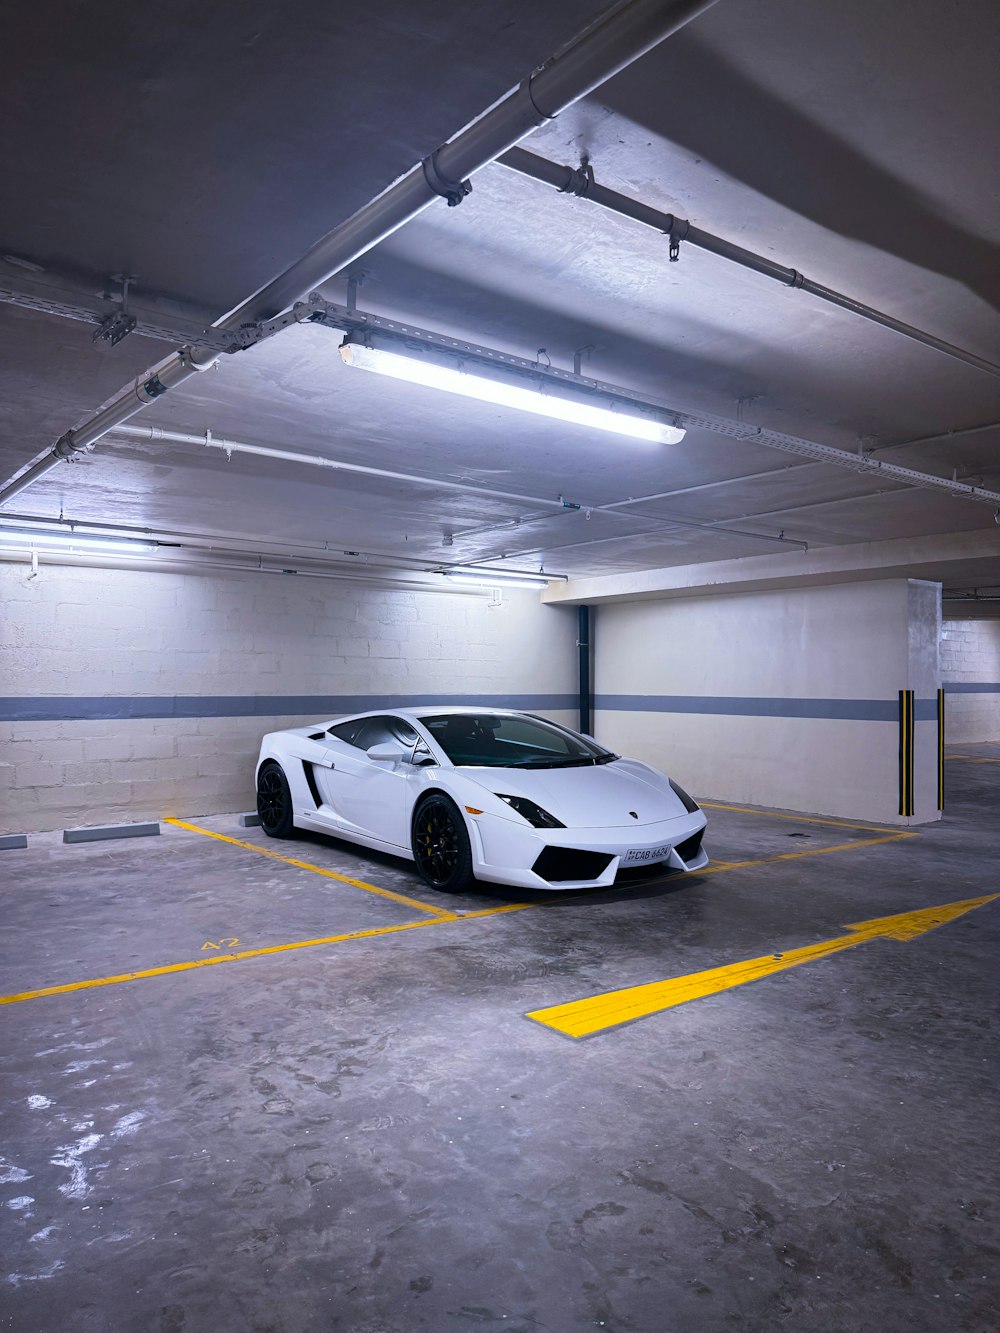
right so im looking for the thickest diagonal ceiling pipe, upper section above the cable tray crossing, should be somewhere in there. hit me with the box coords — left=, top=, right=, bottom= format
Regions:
left=216, top=0, right=716, bottom=328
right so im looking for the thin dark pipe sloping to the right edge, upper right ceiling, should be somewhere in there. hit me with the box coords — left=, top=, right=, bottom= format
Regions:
left=497, top=148, right=1000, bottom=376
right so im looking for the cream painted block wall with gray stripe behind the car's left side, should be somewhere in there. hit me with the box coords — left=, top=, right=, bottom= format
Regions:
left=0, top=563, right=577, bottom=832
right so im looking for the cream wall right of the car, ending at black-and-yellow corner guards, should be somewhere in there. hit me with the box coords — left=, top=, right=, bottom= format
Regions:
left=593, top=580, right=940, bottom=824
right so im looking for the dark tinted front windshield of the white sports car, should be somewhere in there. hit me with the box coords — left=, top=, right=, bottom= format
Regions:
left=420, top=713, right=617, bottom=768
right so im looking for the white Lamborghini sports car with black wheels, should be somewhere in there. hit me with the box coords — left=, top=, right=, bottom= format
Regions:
left=257, top=708, right=708, bottom=893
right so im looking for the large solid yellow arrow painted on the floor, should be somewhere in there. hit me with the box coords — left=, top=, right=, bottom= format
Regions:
left=525, top=893, right=1000, bottom=1038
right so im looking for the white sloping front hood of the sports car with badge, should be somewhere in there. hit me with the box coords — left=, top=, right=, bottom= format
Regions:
left=469, top=758, right=688, bottom=829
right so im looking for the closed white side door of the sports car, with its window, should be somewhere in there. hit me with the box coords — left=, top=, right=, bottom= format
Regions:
left=315, top=714, right=419, bottom=846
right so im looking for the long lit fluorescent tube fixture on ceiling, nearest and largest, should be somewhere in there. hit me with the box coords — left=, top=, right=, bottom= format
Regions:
left=340, top=332, right=684, bottom=444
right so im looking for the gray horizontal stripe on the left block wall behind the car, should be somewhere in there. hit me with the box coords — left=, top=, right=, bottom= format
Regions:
left=0, top=694, right=580, bottom=722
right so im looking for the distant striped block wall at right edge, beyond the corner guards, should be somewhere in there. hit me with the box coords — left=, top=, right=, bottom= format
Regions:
left=941, top=620, right=1000, bottom=745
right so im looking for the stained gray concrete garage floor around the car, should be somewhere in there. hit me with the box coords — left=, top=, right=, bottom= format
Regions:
left=0, top=745, right=1000, bottom=1333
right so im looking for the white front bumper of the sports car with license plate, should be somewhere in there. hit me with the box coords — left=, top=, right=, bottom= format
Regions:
left=469, top=810, right=708, bottom=889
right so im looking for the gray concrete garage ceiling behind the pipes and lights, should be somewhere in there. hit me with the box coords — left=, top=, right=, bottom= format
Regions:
left=0, top=0, right=1000, bottom=605
